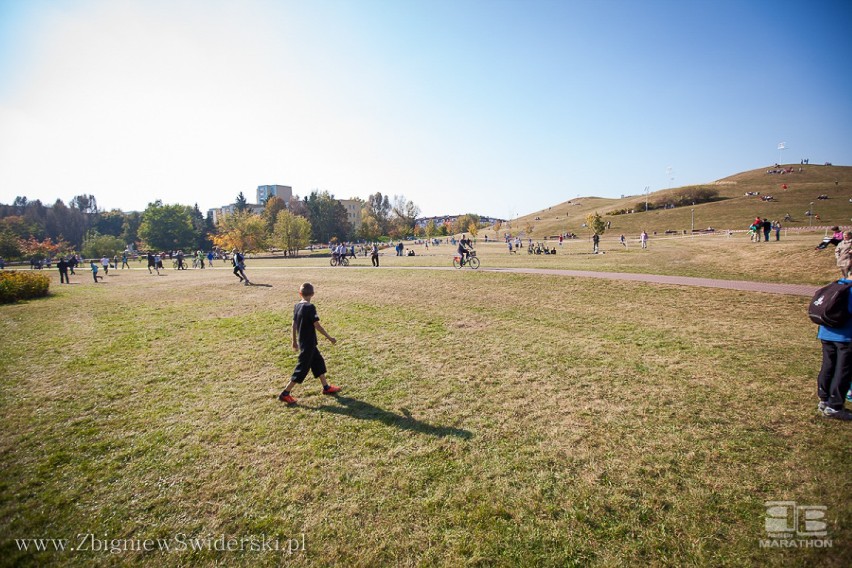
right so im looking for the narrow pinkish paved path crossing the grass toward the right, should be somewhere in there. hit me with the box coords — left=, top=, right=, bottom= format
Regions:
left=394, top=266, right=818, bottom=296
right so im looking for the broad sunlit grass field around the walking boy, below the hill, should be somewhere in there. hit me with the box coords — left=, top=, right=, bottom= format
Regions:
left=0, top=235, right=852, bottom=566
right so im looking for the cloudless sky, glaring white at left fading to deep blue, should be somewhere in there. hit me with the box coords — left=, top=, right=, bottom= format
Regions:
left=0, top=0, right=852, bottom=218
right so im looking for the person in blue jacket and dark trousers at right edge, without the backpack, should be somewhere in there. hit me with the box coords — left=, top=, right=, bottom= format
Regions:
left=817, top=279, right=852, bottom=420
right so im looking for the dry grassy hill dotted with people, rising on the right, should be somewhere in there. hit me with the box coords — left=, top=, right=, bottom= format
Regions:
left=490, top=164, right=852, bottom=239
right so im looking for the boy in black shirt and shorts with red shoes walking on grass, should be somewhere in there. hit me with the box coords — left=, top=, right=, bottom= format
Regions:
left=278, top=282, right=340, bottom=404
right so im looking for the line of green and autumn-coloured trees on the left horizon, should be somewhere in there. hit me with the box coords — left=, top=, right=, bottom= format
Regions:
left=0, top=190, right=432, bottom=259
